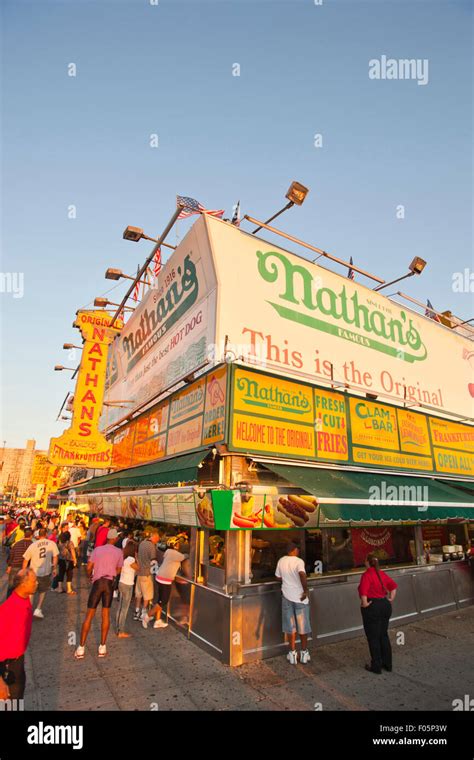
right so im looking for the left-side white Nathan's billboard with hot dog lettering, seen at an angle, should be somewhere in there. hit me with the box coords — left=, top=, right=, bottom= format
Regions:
left=101, top=225, right=216, bottom=428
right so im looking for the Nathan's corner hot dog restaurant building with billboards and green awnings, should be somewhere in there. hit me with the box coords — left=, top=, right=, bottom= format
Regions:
left=55, top=215, right=474, bottom=665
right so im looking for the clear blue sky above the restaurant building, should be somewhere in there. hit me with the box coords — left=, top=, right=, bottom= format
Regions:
left=0, top=0, right=473, bottom=448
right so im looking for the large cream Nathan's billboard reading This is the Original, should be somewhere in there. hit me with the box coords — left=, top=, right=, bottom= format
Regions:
left=204, top=216, right=474, bottom=418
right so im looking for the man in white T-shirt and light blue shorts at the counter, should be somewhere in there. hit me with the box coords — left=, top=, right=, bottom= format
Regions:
left=275, top=542, right=311, bottom=665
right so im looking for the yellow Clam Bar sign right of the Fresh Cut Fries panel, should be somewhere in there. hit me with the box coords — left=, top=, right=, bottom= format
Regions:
left=350, top=398, right=399, bottom=451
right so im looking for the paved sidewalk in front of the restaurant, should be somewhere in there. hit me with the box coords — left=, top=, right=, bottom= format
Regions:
left=0, top=557, right=474, bottom=711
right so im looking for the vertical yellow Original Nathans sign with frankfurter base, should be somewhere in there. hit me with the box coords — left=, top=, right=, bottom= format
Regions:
left=48, top=311, right=123, bottom=469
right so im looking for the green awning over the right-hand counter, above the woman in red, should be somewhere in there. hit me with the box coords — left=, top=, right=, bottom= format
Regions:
left=259, top=460, right=474, bottom=522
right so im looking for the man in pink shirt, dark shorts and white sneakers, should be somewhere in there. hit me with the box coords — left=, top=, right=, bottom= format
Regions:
left=74, top=528, right=123, bottom=660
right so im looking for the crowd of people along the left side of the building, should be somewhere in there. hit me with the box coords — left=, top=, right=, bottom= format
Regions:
left=0, top=506, right=189, bottom=700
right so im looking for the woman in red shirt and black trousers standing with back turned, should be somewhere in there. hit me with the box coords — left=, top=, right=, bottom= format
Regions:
left=359, top=554, right=397, bottom=674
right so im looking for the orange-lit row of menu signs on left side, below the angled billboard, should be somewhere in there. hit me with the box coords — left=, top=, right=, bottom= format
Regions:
left=112, top=367, right=227, bottom=469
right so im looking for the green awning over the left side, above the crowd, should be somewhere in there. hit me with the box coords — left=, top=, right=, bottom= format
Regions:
left=70, top=449, right=209, bottom=493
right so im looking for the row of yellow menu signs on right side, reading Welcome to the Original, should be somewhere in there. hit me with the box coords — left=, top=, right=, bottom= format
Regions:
left=228, top=367, right=474, bottom=477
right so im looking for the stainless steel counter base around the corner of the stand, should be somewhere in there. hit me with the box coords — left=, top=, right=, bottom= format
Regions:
left=164, top=561, right=474, bottom=665
